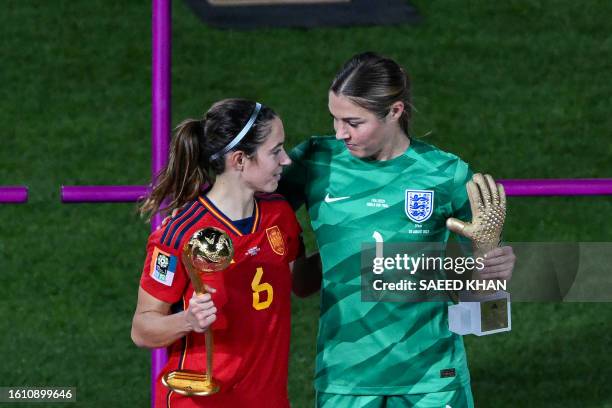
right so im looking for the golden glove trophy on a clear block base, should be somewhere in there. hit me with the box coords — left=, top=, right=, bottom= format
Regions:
left=446, top=174, right=512, bottom=336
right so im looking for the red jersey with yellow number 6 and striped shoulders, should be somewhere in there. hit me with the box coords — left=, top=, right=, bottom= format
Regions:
left=140, top=194, right=301, bottom=408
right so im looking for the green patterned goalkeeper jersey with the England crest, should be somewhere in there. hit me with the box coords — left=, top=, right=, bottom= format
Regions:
left=279, top=137, right=472, bottom=395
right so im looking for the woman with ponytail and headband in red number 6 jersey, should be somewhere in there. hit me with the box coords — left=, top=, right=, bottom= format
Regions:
left=132, top=99, right=314, bottom=408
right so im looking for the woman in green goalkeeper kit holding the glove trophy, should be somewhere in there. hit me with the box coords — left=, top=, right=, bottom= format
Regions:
left=279, top=53, right=515, bottom=408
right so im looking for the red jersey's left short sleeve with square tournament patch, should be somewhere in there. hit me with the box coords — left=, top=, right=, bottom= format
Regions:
left=140, top=230, right=189, bottom=304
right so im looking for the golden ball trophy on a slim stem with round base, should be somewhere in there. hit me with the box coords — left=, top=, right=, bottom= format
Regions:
left=162, top=227, right=234, bottom=396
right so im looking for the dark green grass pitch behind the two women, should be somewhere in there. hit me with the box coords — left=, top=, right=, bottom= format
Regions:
left=0, top=0, right=612, bottom=408
